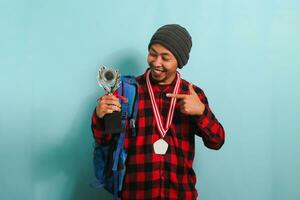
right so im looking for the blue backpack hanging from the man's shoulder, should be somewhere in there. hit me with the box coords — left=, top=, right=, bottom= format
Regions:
left=91, top=76, right=138, bottom=199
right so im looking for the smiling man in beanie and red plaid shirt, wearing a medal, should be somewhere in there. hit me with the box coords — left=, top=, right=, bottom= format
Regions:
left=92, top=24, right=225, bottom=199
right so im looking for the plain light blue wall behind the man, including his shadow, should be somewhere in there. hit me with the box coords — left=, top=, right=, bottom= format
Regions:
left=0, top=0, right=300, bottom=200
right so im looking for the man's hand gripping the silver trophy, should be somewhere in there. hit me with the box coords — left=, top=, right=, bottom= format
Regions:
left=96, top=94, right=121, bottom=118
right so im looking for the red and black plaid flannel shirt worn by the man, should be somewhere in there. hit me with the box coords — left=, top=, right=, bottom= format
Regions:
left=92, top=70, right=225, bottom=199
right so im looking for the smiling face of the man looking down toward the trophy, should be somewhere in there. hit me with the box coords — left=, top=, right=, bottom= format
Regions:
left=147, top=44, right=178, bottom=85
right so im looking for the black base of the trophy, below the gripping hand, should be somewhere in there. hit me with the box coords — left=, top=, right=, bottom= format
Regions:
left=103, top=112, right=123, bottom=134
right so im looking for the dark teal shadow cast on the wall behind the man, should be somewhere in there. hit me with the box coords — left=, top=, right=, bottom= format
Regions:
left=33, top=50, right=146, bottom=200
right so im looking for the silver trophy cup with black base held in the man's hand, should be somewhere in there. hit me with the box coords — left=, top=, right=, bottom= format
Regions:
left=97, top=66, right=122, bottom=134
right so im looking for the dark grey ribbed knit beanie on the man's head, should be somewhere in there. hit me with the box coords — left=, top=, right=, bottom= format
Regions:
left=148, top=24, right=192, bottom=69
